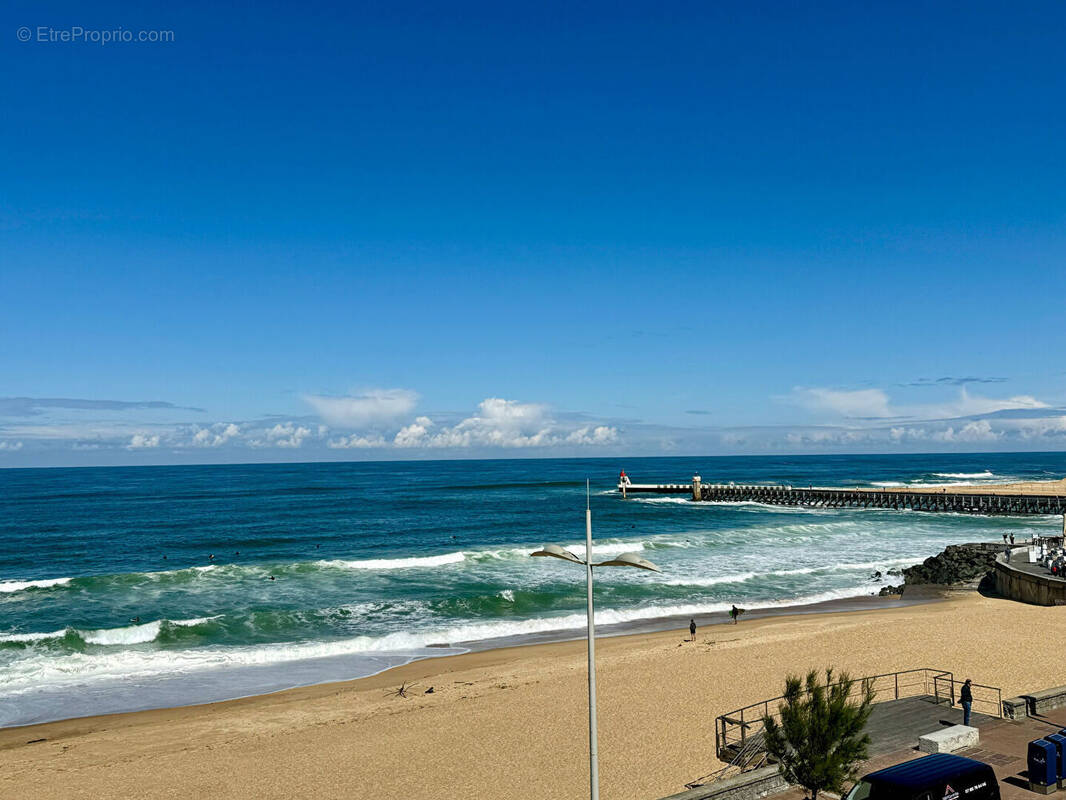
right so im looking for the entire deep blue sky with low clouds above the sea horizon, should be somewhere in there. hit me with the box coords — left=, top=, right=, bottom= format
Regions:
left=0, top=0, right=1066, bottom=467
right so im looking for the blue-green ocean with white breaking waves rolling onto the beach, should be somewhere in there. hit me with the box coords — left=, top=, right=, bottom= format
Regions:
left=0, top=453, right=1066, bottom=726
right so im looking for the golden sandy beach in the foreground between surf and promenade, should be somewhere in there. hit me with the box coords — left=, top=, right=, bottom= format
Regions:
left=8, top=592, right=1066, bottom=799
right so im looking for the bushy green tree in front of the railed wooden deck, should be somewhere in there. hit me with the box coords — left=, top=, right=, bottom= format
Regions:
left=762, top=669, right=874, bottom=800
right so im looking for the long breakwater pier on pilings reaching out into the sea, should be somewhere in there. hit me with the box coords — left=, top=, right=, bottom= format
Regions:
left=618, top=475, right=1066, bottom=514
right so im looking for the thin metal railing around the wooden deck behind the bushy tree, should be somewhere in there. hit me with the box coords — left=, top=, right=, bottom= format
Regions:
left=714, top=667, right=1003, bottom=762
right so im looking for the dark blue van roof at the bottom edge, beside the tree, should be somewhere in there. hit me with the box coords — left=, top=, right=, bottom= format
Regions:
left=844, top=753, right=1000, bottom=800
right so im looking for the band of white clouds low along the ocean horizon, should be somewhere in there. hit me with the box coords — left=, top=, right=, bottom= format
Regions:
left=0, top=380, right=1066, bottom=466
